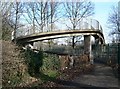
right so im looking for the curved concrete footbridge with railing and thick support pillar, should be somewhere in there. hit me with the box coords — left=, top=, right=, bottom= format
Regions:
left=13, top=19, right=105, bottom=63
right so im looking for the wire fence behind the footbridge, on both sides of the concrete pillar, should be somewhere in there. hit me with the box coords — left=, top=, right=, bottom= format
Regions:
left=35, top=43, right=120, bottom=64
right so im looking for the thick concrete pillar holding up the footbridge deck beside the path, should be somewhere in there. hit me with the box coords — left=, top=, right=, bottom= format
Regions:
left=84, top=35, right=93, bottom=64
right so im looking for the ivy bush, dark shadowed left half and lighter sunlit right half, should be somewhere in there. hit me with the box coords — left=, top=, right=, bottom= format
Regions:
left=25, top=49, right=60, bottom=78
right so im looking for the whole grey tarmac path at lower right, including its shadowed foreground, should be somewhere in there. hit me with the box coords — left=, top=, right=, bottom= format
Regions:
left=54, top=64, right=120, bottom=89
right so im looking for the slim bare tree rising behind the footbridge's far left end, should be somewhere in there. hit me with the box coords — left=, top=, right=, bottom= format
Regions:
left=7, top=0, right=24, bottom=43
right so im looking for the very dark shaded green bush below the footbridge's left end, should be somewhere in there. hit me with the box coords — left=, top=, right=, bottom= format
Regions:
left=25, top=49, right=43, bottom=76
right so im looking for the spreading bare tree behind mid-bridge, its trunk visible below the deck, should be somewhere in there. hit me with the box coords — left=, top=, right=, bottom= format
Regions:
left=64, top=0, right=94, bottom=48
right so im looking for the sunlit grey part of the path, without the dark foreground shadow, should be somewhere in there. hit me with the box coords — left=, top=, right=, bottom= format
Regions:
left=73, top=64, right=120, bottom=89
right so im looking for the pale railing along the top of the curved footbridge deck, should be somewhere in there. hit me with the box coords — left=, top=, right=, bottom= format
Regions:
left=15, top=19, right=102, bottom=38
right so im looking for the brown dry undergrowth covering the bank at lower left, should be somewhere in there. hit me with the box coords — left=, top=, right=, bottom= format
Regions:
left=2, top=41, right=37, bottom=87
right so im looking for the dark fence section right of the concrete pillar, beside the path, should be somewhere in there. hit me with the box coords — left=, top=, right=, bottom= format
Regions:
left=93, top=43, right=120, bottom=64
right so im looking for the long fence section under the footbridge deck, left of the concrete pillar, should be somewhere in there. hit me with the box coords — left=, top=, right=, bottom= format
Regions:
left=35, top=43, right=84, bottom=55
